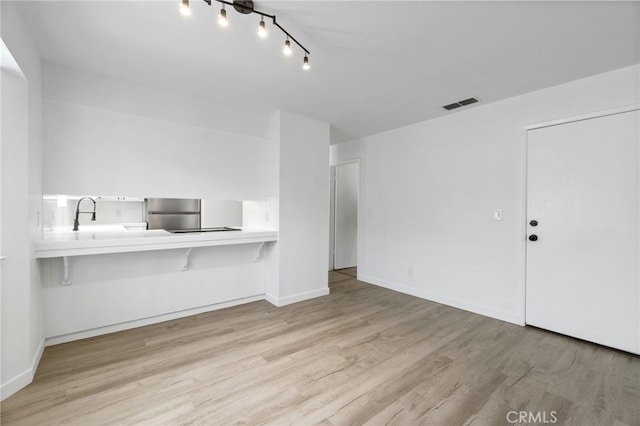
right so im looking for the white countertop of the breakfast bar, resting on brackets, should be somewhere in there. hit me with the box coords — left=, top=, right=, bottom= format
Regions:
left=36, top=225, right=278, bottom=258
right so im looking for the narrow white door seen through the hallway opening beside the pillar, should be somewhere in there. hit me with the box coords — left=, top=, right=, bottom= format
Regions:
left=334, top=163, right=360, bottom=269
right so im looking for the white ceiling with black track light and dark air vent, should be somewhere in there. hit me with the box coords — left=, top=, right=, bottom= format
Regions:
left=13, top=0, right=640, bottom=143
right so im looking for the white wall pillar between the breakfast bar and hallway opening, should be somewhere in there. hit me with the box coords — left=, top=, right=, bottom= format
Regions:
left=267, top=112, right=329, bottom=306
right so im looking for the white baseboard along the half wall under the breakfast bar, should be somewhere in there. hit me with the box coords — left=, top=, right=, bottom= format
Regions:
left=45, top=294, right=265, bottom=346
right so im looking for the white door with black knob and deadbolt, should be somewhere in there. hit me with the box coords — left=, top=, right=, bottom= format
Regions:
left=526, top=110, right=640, bottom=353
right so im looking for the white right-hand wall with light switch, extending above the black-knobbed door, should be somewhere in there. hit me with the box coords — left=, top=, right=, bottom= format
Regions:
left=331, top=66, right=640, bottom=324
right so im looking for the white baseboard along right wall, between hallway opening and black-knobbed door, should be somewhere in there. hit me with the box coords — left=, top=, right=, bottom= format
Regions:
left=358, top=274, right=524, bottom=325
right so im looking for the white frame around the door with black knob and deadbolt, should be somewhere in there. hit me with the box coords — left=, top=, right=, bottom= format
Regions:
left=518, top=104, right=640, bottom=326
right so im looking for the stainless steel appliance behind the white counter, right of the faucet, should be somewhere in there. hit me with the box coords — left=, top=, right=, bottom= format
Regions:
left=145, top=198, right=200, bottom=231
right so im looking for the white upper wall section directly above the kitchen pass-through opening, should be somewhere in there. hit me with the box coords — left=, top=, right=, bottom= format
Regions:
left=43, top=64, right=268, bottom=200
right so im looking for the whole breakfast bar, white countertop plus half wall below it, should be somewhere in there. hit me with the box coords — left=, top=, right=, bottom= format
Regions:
left=35, top=223, right=278, bottom=344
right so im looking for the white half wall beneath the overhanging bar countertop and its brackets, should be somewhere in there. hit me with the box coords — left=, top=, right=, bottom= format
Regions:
left=41, top=243, right=265, bottom=344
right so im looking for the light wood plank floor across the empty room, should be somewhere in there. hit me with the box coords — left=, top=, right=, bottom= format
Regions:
left=2, top=271, right=640, bottom=426
